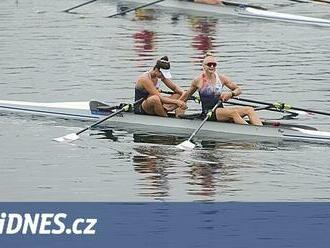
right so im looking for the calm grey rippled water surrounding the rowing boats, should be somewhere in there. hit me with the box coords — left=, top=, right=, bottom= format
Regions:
left=0, top=0, right=330, bottom=201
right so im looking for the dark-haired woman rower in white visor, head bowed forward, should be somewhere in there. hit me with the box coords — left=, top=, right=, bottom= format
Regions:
left=134, top=56, right=187, bottom=116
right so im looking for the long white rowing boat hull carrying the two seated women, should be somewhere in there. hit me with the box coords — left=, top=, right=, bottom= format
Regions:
left=0, top=100, right=330, bottom=144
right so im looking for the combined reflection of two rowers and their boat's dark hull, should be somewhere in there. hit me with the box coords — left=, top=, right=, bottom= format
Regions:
left=98, top=130, right=255, bottom=201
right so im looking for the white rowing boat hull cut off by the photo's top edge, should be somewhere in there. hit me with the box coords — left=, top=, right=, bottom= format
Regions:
left=126, top=0, right=330, bottom=27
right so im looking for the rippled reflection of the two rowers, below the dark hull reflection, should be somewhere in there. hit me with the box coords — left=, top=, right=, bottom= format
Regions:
left=132, top=146, right=225, bottom=200
